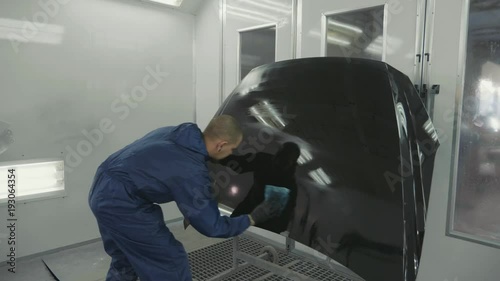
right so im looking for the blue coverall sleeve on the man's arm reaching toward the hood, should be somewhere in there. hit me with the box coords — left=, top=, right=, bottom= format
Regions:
left=170, top=166, right=250, bottom=238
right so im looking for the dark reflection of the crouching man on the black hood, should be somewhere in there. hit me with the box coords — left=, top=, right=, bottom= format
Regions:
left=219, top=142, right=300, bottom=233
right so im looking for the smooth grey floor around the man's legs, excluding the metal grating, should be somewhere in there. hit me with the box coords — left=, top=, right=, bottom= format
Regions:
left=0, top=221, right=225, bottom=281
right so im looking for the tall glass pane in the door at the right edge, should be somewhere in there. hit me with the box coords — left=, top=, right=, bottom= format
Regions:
left=452, top=0, right=500, bottom=244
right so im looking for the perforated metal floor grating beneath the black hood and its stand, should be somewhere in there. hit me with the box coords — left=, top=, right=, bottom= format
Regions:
left=189, top=237, right=352, bottom=281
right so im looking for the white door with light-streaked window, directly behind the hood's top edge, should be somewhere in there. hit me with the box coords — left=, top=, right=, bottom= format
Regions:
left=297, top=0, right=423, bottom=84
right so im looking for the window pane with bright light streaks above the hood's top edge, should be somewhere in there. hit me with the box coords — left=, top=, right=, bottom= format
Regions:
left=326, top=6, right=384, bottom=61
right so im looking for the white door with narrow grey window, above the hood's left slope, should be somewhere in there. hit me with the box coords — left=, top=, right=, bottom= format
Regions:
left=223, top=0, right=295, bottom=99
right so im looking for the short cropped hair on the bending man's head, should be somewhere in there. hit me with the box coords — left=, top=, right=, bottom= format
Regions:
left=203, top=115, right=243, bottom=144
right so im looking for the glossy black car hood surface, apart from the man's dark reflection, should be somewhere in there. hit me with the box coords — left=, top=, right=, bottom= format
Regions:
left=211, top=58, right=439, bottom=281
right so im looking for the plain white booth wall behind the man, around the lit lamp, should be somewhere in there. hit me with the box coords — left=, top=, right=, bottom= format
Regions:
left=0, top=0, right=195, bottom=260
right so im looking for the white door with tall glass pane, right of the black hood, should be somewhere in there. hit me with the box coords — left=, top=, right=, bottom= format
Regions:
left=417, top=0, right=500, bottom=281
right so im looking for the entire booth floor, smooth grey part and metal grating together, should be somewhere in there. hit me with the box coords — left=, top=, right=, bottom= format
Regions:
left=0, top=221, right=360, bottom=281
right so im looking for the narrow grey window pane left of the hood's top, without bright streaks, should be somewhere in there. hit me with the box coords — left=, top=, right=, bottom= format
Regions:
left=240, top=27, right=276, bottom=80
